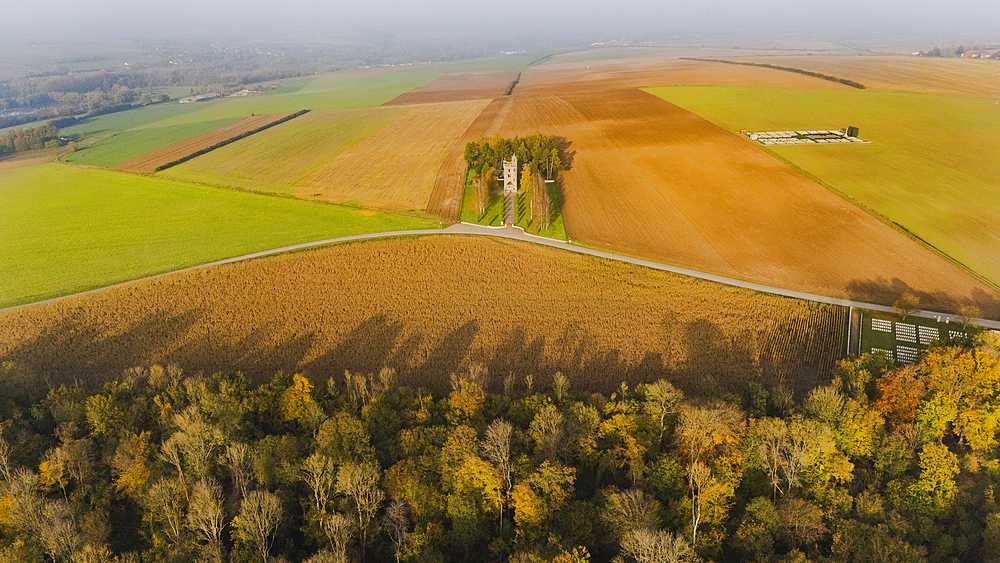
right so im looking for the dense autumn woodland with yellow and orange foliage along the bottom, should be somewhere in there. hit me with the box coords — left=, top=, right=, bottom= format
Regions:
left=0, top=333, right=1000, bottom=563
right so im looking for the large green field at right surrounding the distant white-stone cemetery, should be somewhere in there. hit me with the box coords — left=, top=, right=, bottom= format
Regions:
left=648, top=87, right=1000, bottom=284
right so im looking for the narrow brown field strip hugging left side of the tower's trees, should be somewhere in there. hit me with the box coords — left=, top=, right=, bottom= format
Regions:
left=427, top=96, right=511, bottom=221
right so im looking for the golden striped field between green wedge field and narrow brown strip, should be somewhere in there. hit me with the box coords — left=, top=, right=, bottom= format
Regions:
left=294, top=100, right=489, bottom=210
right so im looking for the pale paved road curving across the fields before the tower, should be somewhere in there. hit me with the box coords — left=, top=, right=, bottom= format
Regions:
left=3, top=223, right=1000, bottom=330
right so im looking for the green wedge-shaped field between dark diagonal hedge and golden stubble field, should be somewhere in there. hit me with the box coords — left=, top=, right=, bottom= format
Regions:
left=161, top=108, right=408, bottom=194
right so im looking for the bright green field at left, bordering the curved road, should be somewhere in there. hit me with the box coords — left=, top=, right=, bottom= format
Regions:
left=0, top=164, right=438, bottom=308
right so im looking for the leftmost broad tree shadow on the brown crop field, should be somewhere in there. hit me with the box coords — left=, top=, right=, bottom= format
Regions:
left=2, top=309, right=201, bottom=385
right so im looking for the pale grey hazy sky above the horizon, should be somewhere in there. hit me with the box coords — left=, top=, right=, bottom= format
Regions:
left=0, top=0, right=1000, bottom=41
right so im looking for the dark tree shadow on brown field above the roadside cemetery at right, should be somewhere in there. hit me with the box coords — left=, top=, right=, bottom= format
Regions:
left=847, top=278, right=1000, bottom=319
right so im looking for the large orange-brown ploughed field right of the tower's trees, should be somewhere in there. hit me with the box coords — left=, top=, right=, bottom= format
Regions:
left=501, top=86, right=1000, bottom=316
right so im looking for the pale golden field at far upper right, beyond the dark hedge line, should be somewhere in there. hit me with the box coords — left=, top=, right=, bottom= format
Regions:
left=717, top=55, right=1000, bottom=98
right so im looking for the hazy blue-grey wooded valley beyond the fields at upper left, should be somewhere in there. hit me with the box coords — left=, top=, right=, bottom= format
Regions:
left=0, top=40, right=508, bottom=132
